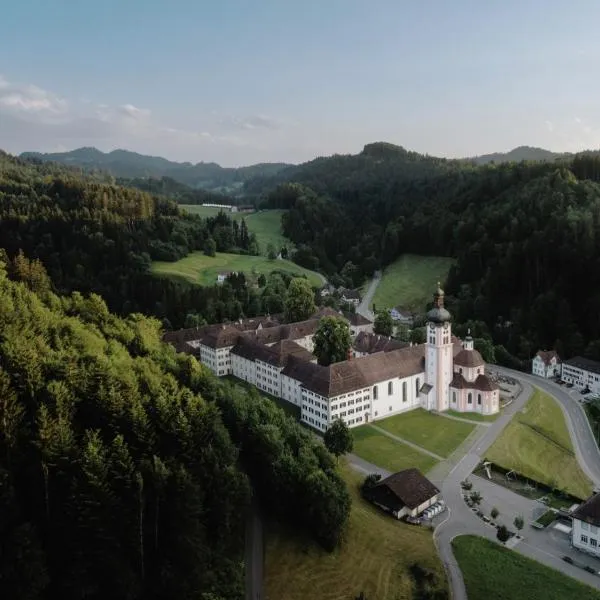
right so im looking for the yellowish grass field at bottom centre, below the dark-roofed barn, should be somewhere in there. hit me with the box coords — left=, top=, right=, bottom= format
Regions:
left=265, top=465, right=447, bottom=600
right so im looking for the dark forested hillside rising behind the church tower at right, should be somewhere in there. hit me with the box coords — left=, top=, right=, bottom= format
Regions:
left=247, top=144, right=600, bottom=359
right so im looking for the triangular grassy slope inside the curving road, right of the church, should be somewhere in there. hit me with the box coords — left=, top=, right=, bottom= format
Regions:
left=486, top=388, right=592, bottom=499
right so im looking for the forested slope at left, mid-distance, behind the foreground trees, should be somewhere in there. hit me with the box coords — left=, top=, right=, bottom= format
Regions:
left=0, top=152, right=294, bottom=328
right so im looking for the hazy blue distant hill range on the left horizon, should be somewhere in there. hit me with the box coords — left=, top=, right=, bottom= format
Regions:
left=21, top=148, right=288, bottom=193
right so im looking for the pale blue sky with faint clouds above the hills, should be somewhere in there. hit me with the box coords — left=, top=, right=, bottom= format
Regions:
left=0, top=0, right=600, bottom=166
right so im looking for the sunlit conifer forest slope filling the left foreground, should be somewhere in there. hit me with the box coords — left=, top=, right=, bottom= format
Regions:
left=0, top=255, right=350, bottom=600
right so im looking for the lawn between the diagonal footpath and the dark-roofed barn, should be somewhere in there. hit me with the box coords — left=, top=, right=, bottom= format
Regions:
left=352, top=426, right=436, bottom=473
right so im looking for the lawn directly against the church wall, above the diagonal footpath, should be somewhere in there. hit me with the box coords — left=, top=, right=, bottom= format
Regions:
left=376, top=408, right=476, bottom=457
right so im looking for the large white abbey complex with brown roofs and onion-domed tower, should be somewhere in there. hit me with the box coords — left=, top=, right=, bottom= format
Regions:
left=165, top=284, right=500, bottom=431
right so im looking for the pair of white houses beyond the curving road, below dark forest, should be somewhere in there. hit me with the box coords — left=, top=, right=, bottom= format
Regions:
left=531, top=350, right=600, bottom=395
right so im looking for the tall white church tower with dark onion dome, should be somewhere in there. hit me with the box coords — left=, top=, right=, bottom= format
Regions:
left=424, top=283, right=453, bottom=411
